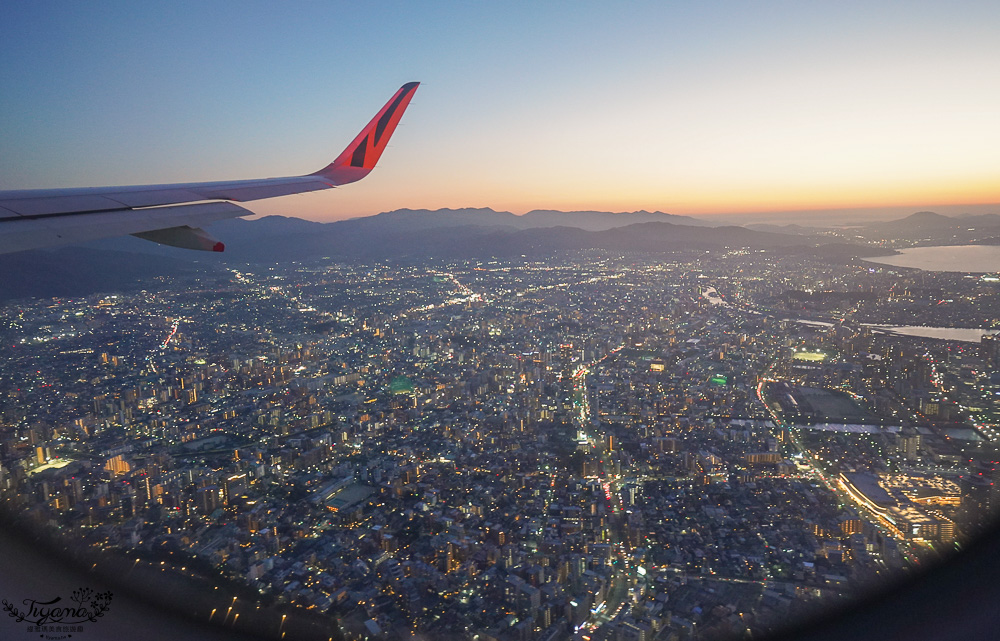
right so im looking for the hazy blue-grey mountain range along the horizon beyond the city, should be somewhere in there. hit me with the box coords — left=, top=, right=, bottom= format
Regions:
left=0, top=208, right=980, bottom=299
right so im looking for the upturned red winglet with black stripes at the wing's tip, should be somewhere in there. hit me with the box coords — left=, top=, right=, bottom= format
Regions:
left=310, top=82, right=420, bottom=185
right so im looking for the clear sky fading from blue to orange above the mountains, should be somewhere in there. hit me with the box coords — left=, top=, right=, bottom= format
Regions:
left=0, top=0, right=1000, bottom=222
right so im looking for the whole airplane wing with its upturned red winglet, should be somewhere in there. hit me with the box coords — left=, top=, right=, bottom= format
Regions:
left=0, top=82, right=420, bottom=254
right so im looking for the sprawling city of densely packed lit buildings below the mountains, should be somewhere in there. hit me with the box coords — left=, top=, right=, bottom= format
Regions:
left=0, top=250, right=1000, bottom=641
